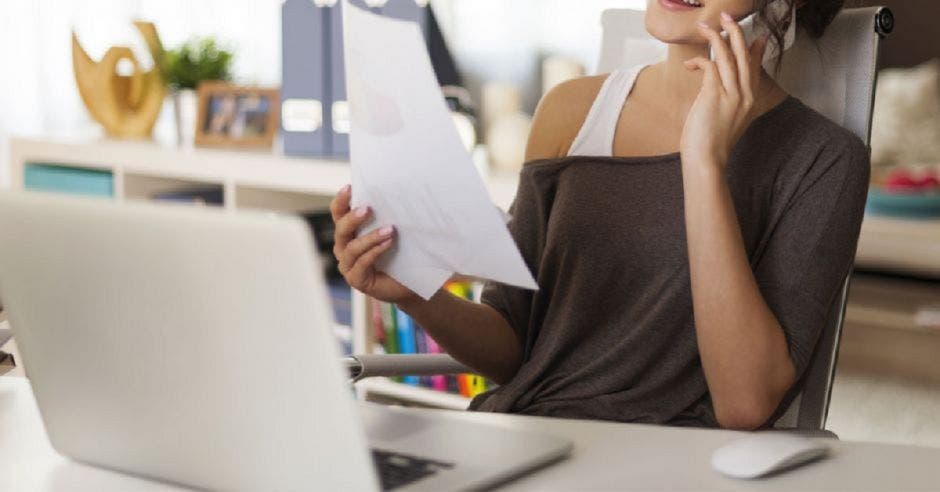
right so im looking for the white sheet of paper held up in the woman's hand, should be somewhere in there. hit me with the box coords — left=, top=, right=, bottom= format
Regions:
left=343, top=0, right=537, bottom=299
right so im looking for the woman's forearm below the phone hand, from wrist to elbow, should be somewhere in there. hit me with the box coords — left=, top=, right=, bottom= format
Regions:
left=683, top=166, right=796, bottom=429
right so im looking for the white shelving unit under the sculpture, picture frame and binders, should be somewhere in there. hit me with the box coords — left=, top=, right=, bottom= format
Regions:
left=10, top=138, right=517, bottom=409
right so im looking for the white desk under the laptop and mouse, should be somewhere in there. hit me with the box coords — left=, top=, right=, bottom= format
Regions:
left=0, top=377, right=940, bottom=492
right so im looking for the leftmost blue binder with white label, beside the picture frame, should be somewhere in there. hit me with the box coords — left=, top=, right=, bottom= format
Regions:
left=281, top=0, right=331, bottom=157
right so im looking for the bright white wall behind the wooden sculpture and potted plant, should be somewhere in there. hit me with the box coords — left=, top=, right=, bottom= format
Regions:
left=0, top=0, right=281, bottom=187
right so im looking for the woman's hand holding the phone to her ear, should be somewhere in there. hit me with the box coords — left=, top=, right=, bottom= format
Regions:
left=679, top=12, right=767, bottom=169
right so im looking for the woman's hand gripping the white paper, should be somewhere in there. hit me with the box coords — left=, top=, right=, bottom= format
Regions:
left=330, top=185, right=417, bottom=303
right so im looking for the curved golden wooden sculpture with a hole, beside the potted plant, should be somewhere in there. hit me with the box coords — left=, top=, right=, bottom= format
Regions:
left=72, top=22, right=166, bottom=138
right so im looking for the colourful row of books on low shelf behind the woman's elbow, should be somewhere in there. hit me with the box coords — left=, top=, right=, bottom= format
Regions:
left=370, top=282, right=493, bottom=398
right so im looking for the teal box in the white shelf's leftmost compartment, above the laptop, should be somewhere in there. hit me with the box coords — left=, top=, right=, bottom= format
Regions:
left=23, top=164, right=114, bottom=198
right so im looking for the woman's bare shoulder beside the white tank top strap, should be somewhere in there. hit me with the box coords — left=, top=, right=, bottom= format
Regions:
left=526, top=74, right=607, bottom=162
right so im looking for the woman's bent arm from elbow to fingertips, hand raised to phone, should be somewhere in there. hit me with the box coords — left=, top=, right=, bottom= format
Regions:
left=681, top=16, right=796, bottom=429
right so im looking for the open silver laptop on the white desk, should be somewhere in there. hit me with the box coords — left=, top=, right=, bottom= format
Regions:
left=0, top=193, right=571, bottom=490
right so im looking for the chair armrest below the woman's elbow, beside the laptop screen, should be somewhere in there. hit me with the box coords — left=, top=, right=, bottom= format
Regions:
left=343, top=354, right=473, bottom=382
